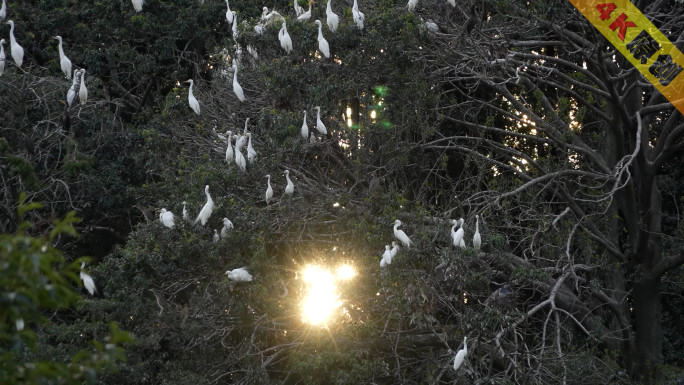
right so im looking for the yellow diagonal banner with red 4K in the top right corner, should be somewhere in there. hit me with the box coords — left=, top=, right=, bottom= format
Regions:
left=570, top=0, right=684, bottom=114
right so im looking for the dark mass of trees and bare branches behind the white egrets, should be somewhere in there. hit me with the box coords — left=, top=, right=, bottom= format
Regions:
left=0, top=0, right=684, bottom=384
